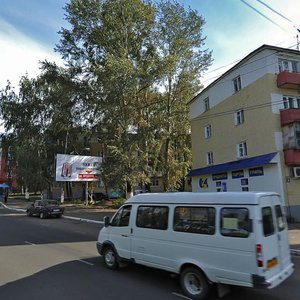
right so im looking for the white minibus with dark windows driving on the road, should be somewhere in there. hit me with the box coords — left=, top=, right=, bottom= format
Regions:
left=97, top=192, right=294, bottom=299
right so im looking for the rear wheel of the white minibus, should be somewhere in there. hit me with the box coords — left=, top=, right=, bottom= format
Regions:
left=180, top=267, right=209, bottom=300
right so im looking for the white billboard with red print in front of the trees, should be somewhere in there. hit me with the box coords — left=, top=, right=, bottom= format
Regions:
left=56, top=154, right=102, bottom=181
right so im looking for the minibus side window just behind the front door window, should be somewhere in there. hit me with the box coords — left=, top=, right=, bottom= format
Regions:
left=136, top=206, right=169, bottom=230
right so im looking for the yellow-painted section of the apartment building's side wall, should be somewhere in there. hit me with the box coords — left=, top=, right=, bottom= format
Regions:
left=191, top=74, right=281, bottom=169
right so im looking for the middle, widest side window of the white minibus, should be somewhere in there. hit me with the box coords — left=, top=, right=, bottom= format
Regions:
left=173, top=206, right=216, bottom=234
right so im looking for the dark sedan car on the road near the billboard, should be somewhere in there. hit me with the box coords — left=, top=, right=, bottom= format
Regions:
left=26, top=200, right=64, bottom=219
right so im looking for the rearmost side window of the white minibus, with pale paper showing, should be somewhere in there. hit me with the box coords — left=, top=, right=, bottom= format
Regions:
left=221, top=208, right=251, bottom=238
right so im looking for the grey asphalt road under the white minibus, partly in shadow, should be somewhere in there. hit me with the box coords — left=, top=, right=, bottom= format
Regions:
left=0, top=209, right=300, bottom=300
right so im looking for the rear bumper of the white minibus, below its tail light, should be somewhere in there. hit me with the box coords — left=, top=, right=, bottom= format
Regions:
left=252, top=263, right=294, bottom=289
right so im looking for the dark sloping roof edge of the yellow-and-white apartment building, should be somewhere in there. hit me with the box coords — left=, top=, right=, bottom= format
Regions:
left=188, top=45, right=300, bottom=105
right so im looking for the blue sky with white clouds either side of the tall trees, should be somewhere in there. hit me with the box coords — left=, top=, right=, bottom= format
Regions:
left=0, top=0, right=300, bottom=90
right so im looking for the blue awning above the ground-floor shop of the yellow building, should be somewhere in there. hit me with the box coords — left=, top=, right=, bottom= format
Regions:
left=187, top=152, right=277, bottom=177
